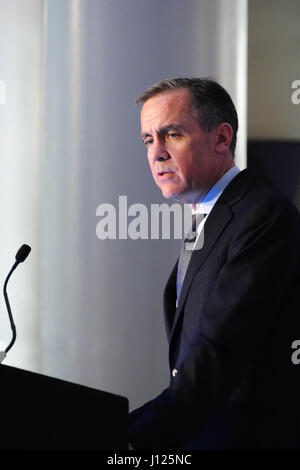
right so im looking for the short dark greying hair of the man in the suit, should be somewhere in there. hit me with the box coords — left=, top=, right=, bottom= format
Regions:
left=136, top=78, right=238, bottom=156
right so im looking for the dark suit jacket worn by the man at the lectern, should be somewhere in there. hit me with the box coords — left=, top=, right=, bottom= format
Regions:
left=129, top=170, right=300, bottom=449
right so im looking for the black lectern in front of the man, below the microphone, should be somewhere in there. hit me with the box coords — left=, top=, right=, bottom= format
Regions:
left=0, top=365, right=128, bottom=450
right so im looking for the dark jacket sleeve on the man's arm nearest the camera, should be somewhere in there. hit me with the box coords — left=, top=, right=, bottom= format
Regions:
left=129, top=197, right=300, bottom=449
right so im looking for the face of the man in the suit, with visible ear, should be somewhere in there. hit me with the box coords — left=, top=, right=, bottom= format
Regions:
left=141, top=88, right=232, bottom=203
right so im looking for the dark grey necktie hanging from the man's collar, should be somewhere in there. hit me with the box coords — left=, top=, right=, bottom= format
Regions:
left=176, top=214, right=205, bottom=307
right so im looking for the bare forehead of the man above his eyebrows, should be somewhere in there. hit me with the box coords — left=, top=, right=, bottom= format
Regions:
left=141, top=88, right=194, bottom=129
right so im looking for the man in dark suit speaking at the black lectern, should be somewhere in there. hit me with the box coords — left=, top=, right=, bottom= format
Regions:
left=129, top=78, right=300, bottom=449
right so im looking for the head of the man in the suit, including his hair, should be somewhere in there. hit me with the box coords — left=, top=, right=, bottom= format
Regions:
left=137, top=78, right=238, bottom=203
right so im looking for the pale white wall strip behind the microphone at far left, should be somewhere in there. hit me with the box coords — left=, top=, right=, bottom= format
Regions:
left=0, top=0, right=43, bottom=370
